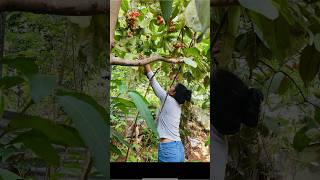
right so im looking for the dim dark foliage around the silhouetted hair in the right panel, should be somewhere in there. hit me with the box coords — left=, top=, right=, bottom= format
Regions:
left=211, top=0, right=320, bottom=179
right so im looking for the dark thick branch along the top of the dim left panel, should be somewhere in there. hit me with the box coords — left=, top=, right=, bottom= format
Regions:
left=0, top=0, right=110, bottom=16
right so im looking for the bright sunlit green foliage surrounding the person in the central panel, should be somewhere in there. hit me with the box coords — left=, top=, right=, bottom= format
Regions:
left=110, top=0, right=210, bottom=162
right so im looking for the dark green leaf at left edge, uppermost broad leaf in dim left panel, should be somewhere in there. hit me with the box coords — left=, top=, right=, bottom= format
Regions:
left=1, top=57, right=39, bottom=75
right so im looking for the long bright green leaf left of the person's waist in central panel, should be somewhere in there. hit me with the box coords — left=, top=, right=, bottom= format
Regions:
left=128, top=91, right=158, bottom=136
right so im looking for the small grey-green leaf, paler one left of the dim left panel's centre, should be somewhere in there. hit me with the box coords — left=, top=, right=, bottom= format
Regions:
left=28, top=74, right=57, bottom=102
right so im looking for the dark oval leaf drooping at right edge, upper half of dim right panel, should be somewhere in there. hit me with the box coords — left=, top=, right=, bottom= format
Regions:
left=299, top=46, right=320, bottom=86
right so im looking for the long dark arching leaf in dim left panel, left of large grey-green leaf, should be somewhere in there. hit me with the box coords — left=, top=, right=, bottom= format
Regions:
left=7, top=115, right=83, bottom=147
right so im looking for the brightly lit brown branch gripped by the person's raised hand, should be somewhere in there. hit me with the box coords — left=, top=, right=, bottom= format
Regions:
left=110, top=56, right=184, bottom=66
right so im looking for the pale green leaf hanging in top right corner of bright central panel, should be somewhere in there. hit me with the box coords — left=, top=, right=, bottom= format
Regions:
left=195, top=0, right=210, bottom=32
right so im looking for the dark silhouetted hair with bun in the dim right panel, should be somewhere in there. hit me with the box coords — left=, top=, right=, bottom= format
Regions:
left=210, top=69, right=263, bottom=135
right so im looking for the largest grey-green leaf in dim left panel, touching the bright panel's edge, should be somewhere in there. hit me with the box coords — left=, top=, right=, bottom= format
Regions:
left=58, top=94, right=109, bottom=176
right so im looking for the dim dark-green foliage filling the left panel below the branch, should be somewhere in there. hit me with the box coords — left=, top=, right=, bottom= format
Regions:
left=0, top=12, right=109, bottom=179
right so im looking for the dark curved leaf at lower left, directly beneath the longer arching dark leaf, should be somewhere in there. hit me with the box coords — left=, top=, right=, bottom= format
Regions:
left=12, top=131, right=60, bottom=167
